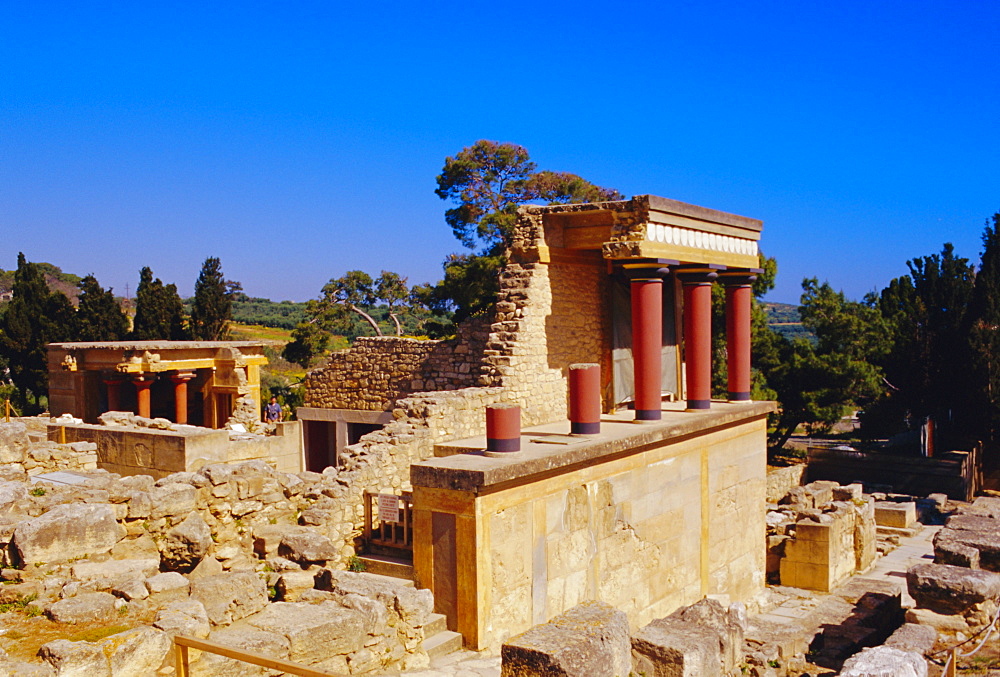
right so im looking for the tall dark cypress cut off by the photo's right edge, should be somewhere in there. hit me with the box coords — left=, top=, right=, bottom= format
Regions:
left=967, top=212, right=1000, bottom=441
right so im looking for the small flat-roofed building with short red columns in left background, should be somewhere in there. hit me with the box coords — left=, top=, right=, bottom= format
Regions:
left=48, top=341, right=267, bottom=428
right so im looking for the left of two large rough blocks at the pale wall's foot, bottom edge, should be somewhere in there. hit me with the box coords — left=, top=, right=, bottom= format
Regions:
left=500, top=602, right=631, bottom=677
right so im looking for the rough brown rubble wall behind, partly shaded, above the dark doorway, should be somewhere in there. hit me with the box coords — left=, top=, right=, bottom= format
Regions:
left=305, top=320, right=487, bottom=411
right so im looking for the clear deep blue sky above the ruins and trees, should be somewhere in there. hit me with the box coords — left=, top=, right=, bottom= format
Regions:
left=0, top=0, right=1000, bottom=302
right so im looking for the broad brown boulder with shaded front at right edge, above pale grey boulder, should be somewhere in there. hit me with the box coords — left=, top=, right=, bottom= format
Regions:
left=906, top=564, right=1000, bottom=614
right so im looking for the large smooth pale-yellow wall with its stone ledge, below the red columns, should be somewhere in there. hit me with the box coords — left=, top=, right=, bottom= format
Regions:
left=411, top=404, right=771, bottom=649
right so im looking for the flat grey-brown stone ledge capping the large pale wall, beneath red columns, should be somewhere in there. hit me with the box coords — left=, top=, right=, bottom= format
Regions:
left=410, top=402, right=777, bottom=493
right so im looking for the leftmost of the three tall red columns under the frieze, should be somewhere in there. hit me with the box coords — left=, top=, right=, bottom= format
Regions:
left=631, top=278, right=663, bottom=421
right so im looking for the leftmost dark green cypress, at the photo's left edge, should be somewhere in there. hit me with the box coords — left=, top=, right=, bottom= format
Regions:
left=0, top=253, right=73, bottom=410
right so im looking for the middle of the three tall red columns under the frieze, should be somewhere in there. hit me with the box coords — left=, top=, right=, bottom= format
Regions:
left=678, top=270, right=718, bottom=409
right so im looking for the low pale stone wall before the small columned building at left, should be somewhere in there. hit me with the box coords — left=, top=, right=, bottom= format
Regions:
left=48, top=421, right=302, bottom=479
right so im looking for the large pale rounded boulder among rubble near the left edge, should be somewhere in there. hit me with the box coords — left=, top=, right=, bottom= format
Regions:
left=14, top=504, right=125, bottom=564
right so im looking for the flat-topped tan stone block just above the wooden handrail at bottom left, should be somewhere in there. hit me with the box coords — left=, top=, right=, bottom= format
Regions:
left=246, top=602, right=367, bottom=663
